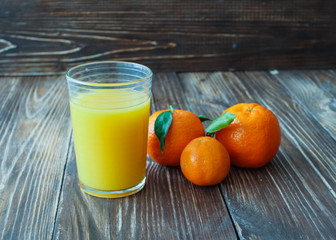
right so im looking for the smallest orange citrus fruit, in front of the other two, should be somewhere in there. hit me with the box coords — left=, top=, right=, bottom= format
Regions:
left=181, top=137, right=230, bottom=186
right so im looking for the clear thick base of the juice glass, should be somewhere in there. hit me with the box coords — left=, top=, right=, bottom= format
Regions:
left=79, top=177, right=146, bottom=198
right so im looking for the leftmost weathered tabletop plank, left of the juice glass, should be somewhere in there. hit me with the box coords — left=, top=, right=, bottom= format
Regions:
left=0, top=77, right=71, bottom=239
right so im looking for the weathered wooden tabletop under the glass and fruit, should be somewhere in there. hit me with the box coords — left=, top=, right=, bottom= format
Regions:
left=0, top=70, right=336, bottom=239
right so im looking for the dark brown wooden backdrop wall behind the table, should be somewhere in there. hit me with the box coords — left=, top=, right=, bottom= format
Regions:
left=0, top=0, right=336, bottom=76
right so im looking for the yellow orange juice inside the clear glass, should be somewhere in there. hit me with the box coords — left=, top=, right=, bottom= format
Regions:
left=70, top=90, right=150, bottom=191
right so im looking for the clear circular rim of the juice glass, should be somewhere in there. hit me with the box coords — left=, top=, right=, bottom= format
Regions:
left=65, top=61, right=153, bottom=87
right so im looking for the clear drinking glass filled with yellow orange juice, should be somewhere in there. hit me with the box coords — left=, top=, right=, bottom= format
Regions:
left=66, top=61, right=152, bottom=198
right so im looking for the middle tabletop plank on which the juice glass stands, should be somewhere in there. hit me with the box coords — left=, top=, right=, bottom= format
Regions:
left=54, top=74, right=237, bottom=239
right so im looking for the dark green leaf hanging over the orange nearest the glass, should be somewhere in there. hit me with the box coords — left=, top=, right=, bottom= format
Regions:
left=154, top=111, right=173, bottom=153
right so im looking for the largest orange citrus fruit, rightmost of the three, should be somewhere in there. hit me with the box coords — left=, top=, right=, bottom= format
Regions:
left=216, top=103, right=281, bottom=168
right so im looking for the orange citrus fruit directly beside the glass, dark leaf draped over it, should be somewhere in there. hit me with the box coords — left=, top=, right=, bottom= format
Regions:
left=147, top=109, right=205, bottom=166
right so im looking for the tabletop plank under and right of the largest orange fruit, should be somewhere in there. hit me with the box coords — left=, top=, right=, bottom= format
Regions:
left=179, top=72, right=336, bottom=239
